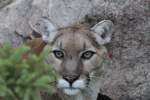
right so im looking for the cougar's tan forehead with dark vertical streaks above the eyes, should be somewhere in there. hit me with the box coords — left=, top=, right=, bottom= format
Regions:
left=54, top=31, right=94, bottom=54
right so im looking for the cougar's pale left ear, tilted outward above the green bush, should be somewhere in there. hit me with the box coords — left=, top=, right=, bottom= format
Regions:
left=29, top=17, right=57, bottom=43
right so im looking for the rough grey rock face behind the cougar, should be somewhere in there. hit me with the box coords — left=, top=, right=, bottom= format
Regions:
left=0, top=0, right=150, bottom=100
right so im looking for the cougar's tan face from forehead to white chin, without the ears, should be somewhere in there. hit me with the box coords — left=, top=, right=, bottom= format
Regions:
left=51, top=31, right=105, bottom=95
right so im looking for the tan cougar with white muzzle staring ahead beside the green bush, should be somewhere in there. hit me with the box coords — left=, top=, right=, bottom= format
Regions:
left=30, top=18, right=113, bottom=100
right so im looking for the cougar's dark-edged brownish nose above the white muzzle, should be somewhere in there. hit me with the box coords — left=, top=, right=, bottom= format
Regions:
left=63, top=75, right=80, bottom=85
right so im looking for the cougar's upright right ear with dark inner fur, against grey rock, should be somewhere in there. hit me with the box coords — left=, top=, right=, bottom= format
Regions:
left=91, top=20, right=113, bottom=45
